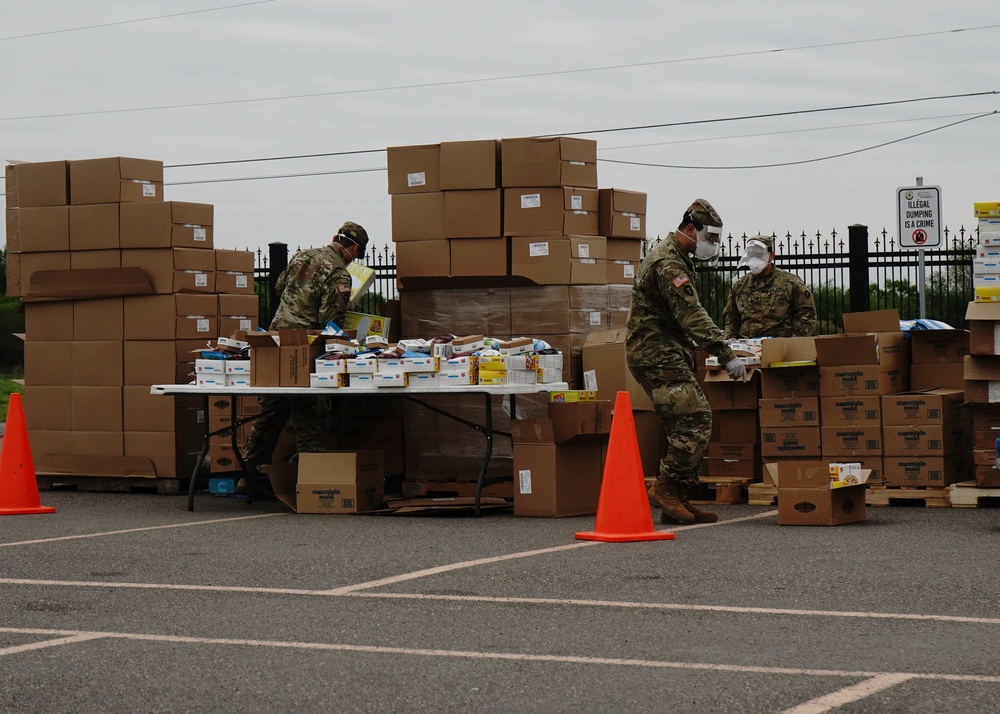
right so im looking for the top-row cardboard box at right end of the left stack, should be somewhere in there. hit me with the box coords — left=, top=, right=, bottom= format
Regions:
left=69, top=157, right=163, bottom=206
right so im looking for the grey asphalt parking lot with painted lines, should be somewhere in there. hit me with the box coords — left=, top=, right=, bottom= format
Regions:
left=0, top=491, right=1000, bottom=714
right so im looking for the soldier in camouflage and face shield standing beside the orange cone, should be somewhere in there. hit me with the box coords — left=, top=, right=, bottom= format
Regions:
left=625, top=198, right=746, bottom=523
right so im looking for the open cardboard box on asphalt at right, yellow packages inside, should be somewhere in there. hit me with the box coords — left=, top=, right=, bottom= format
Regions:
left=764, top=460, right=871, bottom=526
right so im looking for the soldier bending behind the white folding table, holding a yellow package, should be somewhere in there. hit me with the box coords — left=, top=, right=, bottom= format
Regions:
left=243, top=221, right=368, bottom=498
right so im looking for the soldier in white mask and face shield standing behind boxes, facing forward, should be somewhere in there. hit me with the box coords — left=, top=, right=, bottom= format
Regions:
left=725, top=235, right=816, bottom=339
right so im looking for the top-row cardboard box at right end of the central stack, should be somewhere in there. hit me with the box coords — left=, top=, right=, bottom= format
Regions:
left=500, top=137, right=597, bottom=189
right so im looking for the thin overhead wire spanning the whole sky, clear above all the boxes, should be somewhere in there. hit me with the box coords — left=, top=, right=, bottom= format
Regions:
left=0, top=23, right=1000, bottom=121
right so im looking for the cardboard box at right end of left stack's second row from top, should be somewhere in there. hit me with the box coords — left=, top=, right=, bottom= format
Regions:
left=121, top=201, right=215, bottom=249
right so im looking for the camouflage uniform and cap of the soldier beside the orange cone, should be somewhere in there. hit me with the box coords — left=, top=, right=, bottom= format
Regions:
left=625, top=207, right=736, bottom=488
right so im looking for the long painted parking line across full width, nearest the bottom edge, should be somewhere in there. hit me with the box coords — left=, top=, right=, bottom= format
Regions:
left=0, top=627, right=1000, bottom=689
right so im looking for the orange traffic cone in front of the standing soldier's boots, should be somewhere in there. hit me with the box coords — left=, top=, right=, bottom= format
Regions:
left=576, top=392, right=674, bottom=543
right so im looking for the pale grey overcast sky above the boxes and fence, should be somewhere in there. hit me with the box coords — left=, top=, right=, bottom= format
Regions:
left=0, top=0, right=1000, bottom=258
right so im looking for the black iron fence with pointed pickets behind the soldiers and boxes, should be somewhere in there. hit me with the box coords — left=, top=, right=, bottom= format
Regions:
left=254, top=225, right=979, bottom=334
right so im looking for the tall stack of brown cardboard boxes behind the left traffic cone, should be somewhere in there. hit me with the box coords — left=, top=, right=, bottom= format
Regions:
left=6, top=157, right=258, bottom=478
